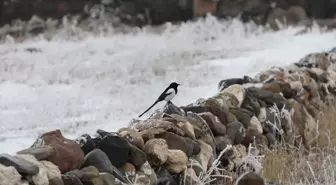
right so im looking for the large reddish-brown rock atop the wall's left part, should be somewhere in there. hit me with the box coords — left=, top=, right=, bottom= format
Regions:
left=32, top=130, right=84, bottom=173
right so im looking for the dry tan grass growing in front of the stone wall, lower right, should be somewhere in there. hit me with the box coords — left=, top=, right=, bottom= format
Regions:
left=262, top=107, right=336, bottom=185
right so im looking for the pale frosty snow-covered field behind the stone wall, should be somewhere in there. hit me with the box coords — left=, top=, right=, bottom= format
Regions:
left=0, top=17, right=336, bottom=153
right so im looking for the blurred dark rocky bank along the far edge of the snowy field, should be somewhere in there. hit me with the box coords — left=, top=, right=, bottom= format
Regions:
left=0, top=0, right=336, bottom=37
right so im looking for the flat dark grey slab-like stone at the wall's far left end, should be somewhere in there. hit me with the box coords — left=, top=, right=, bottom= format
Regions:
left=0, top=154, right=39, bottom=175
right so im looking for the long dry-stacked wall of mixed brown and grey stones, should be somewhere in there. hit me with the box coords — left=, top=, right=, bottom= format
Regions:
left=0, top=46, right=336, bottom=185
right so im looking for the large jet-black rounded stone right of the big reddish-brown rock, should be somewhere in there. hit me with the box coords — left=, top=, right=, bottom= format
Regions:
left=99, top=135, right=131, bottom=168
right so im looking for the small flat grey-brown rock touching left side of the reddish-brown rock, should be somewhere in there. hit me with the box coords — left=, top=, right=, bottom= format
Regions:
left=17, top=145, right=53, bottom=161
